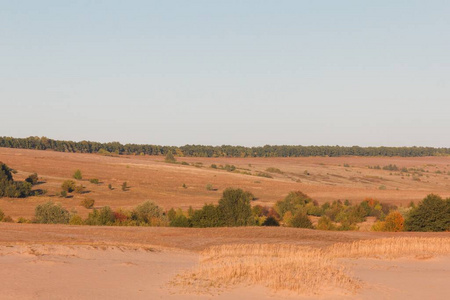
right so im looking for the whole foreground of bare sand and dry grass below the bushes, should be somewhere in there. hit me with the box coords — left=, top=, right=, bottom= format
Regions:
left=0, top=223, right=450, bottom=300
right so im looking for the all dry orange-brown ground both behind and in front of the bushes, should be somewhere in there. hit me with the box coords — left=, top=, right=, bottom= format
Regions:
left=0, top=148, right=450, bottom=300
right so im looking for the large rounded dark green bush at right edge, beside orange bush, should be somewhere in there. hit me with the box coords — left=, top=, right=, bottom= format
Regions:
left=405, top=194, right=450, bottom=231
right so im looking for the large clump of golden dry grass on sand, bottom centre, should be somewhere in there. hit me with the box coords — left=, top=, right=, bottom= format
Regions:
left=172, top=244, right=359, bottom=295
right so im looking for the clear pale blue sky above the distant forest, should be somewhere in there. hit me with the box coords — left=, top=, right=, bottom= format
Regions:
left=0, top=0, right=450, bottom=147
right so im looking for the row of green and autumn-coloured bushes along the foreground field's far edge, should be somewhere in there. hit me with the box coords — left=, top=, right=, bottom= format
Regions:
left=5, top=188, right=450, bottom=232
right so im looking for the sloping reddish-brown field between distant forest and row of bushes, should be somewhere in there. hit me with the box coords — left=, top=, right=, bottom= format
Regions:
left=0, top=148, right=450, bottom=218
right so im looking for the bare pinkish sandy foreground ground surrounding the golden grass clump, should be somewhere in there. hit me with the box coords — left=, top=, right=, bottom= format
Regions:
left=0, top=224, right=450, bottom=299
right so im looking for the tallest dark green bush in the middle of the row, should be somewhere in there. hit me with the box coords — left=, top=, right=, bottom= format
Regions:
left=218, top=188, right=253, bottom=226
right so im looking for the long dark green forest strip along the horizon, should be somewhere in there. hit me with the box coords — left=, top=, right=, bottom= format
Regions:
left=0, top=137, right=450, bottom=157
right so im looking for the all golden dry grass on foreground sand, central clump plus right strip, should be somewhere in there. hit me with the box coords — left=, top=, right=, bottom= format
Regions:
left=172, top=238, right=450, bottom=295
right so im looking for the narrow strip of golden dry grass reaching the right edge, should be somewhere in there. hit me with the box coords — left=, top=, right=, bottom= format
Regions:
left=326, top=237, right=450, bottom=259
